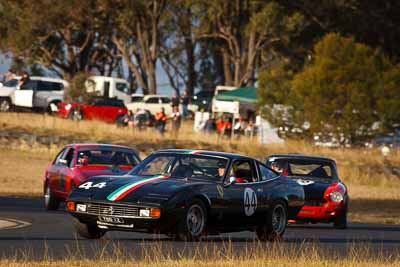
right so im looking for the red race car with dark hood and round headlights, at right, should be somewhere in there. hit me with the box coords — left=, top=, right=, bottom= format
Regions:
left=266, top=154, right=349, bottom=229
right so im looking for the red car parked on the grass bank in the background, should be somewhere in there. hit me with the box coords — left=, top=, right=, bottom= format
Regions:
left=58, top=97, right=128, bottom=123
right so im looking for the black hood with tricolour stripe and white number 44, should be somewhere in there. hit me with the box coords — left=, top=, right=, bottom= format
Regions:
left=69, top=175, right=207, bottom=204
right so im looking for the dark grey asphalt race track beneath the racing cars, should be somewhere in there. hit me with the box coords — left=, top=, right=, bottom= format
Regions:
left=0, top=197, right=400, bottom=259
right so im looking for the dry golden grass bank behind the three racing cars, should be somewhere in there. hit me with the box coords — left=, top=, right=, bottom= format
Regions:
left=0, top=113, right=400, bottom=223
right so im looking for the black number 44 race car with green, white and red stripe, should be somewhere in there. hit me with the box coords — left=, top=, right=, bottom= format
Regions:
left=67, top=149, right=304, bottom=240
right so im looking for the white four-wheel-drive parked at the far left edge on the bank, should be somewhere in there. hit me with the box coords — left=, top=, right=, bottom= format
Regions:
left=0, top=77, right=68, bottom=112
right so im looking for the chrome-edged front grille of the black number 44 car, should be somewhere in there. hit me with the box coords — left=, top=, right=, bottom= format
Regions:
left=85, top=203, right=139, bottom=218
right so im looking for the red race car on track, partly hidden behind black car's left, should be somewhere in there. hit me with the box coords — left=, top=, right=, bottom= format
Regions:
left=44, top=144, right=140, bottom=210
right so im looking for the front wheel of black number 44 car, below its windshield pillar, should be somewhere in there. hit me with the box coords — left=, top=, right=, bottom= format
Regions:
left=172, top=199, right=207, bottom=241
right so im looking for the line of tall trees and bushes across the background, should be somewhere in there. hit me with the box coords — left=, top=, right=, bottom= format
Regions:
left=0, top=0, right=400, bottom=142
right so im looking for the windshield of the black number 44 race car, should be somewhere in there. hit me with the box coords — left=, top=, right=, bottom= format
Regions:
left=130, top=153, right=228, bottom=181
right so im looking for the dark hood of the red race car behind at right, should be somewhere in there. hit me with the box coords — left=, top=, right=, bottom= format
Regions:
left=289, top=176, right=336, bottom=200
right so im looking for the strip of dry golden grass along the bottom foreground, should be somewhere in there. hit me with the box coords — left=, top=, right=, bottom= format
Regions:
left=0, top=242, right=400, bottom=267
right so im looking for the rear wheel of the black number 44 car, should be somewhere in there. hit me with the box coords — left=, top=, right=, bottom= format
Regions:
left=256, top=201, right=288, bottom=241
